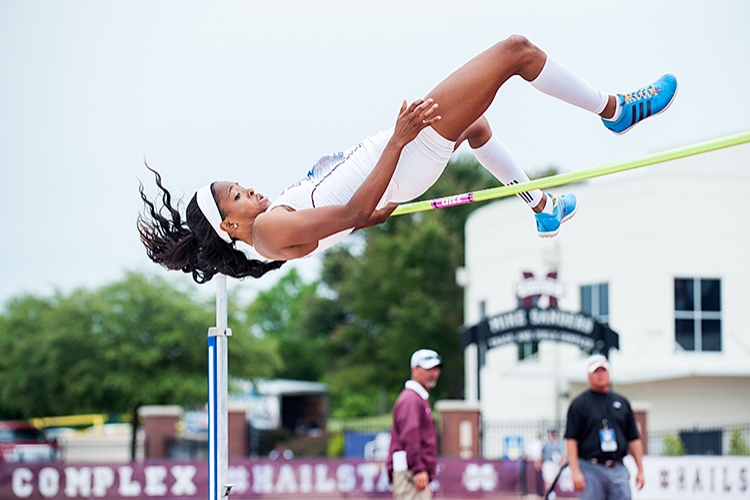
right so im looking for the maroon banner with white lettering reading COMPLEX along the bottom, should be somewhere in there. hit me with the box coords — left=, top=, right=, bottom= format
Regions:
left=0, top=459, right=535, bottom=500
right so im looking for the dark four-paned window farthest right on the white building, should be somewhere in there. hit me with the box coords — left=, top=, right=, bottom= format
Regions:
left=674, top=278, right=721, bottom=351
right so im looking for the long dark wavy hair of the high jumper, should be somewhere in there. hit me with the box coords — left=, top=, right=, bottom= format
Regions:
left=137, top=164, right=284, bottom=283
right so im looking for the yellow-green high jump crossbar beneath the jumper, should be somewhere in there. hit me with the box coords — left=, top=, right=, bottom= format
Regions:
left=391, top=131, right=750, bottom=215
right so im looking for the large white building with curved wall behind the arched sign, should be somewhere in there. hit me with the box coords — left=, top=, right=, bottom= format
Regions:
left=459, top=140, right=750, bottom=453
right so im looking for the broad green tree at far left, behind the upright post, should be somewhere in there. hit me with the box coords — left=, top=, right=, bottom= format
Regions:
left=0, top=273, right=279, bottom=418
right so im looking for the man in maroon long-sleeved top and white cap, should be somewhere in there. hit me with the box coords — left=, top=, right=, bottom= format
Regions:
left=387, top=349, right=442, bottom=500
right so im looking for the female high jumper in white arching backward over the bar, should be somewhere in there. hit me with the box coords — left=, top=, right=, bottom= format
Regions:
left=138, top=35, right=677, bottom=283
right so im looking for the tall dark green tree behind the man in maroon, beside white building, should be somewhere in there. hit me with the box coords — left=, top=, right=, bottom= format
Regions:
left=315, top=157, right=506, bottom=417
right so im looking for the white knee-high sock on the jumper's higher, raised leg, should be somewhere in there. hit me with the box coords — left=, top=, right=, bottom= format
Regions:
left=529, top=56, right=609, bottom=115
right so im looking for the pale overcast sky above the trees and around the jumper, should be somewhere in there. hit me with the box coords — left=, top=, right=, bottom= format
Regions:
left=0, top=0, right=750, bottom=303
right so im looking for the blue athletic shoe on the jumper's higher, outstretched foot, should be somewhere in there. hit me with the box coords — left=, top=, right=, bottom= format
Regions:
left=602, top=74, right=677, bottom=134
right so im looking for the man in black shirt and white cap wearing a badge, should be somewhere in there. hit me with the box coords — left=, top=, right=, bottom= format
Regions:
left=565, top=355, right=643, bottom=500
